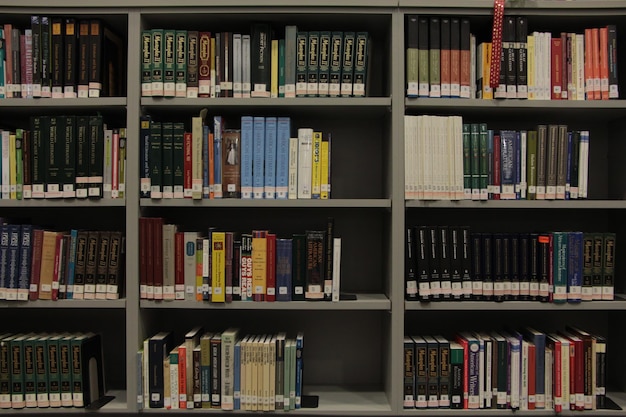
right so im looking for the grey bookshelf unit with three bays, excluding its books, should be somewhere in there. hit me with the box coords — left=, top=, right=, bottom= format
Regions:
left=0, top=0, right=626, bottom=416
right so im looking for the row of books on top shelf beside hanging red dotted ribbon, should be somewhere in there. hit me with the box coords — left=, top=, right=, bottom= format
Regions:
left=406, top=15, right=619, bottom=100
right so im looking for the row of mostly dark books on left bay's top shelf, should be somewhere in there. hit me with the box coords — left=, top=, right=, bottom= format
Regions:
left=0, top=16, right=126, bottom=98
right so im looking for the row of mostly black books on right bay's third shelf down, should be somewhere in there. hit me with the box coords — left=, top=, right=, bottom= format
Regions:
left=406, top=226, right=616, bottom=303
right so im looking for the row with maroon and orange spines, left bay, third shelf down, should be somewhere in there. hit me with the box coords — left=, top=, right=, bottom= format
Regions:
left=0, top=224, right=125, bottom=301
